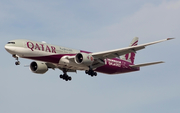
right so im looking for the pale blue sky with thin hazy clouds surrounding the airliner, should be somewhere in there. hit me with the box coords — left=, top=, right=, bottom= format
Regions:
left=0, top=0, right=180, bottom=113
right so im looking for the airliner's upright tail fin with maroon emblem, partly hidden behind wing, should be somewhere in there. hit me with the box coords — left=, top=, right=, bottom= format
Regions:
left=122, top=37, right=139, bottom=64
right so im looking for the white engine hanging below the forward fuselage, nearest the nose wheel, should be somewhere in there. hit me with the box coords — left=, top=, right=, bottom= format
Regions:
left=30, top=61, right=48, bottom=74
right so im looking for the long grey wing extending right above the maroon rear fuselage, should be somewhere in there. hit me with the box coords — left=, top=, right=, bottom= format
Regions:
left=92, top=38, right=174, bottom=59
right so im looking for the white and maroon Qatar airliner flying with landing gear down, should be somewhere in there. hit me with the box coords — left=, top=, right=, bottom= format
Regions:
left=5, top=37, right=174, bottom=81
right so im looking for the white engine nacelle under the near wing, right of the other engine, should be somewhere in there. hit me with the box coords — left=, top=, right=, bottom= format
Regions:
left=75, top=53, right=94, bottom=66
